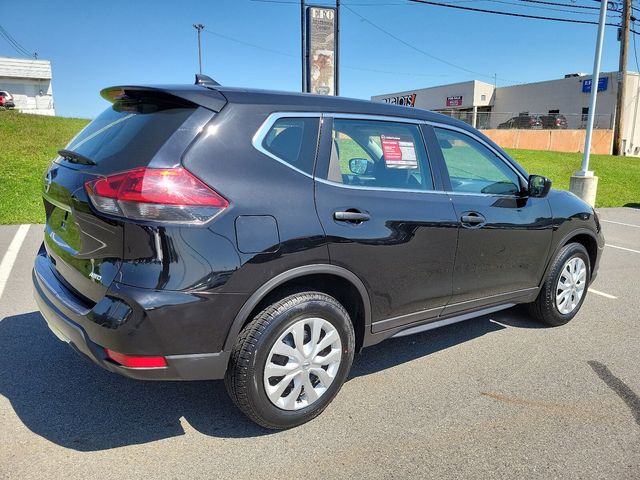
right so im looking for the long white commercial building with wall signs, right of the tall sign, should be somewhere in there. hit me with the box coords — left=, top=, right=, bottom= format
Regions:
left=371, top=72, right=640, bottom=155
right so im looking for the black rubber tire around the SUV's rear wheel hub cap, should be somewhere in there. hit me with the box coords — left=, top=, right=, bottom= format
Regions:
left=225, top=291, right=355, bottom=429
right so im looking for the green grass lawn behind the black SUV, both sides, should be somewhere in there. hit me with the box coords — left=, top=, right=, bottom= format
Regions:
left=0, top=111, right=640, bottom=224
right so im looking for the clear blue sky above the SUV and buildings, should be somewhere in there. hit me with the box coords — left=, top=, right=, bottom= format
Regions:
left=0, top=0, right=635, bottom=118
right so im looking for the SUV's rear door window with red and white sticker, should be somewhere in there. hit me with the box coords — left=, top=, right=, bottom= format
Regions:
left=327, top=118, right=433, bottom=190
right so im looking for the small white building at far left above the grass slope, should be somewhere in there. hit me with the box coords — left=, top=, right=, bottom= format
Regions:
left=0, top=57, right=55, bottom=115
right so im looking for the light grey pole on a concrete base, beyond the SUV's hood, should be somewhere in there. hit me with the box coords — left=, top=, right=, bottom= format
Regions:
left=569, top=0, right=608, bottom=207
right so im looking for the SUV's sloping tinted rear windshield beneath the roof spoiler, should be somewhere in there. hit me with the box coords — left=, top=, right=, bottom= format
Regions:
left=65, top=95, right=196, bottom=167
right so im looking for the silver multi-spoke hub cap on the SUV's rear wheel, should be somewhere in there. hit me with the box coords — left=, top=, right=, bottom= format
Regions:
left=264, top=318, right=342, bottom=410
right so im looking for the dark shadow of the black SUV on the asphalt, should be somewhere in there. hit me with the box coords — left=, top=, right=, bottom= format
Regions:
left=0, top=310, right=537, bottom=451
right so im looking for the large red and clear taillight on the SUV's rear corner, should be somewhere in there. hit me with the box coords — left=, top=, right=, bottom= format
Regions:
left=84, top=168, right=229, bottom=223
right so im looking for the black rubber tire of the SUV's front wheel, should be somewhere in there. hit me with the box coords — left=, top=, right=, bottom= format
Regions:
left=527, top=243, right=591, bottom=327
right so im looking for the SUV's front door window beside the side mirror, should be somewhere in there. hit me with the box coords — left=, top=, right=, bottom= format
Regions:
left=434, top=128, right=520, bottom=195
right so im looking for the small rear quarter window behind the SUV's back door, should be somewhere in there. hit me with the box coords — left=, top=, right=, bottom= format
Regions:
left=262, top=118, right=319, bottom=175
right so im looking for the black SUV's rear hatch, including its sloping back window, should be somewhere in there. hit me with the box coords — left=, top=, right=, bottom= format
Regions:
left=43, top=89, right=218, bottom=304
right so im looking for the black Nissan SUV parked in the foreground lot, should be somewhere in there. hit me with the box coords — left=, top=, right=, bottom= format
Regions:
left=33, top=80, right=604, bottom=428
